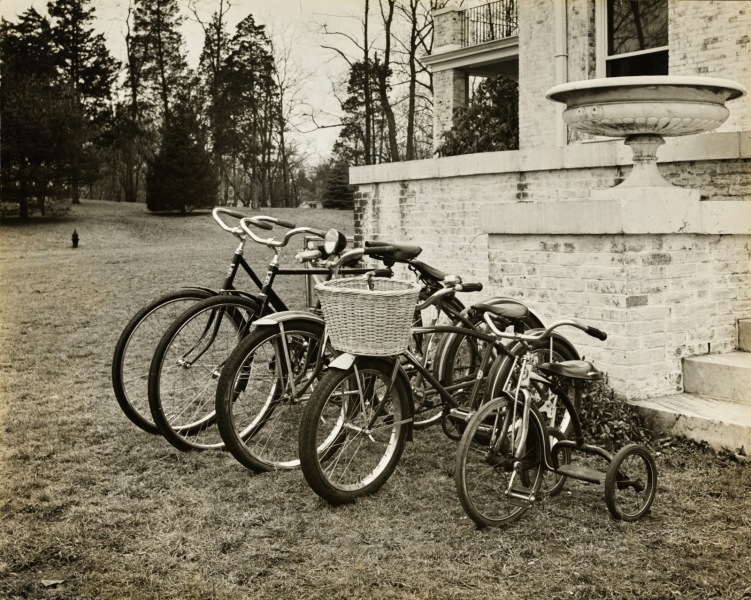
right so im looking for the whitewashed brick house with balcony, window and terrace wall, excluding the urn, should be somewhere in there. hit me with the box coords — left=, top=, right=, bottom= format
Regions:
left=350, top=0, right=751, bottom=399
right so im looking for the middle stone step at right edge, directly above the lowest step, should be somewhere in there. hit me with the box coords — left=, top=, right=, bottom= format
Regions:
left=683, top=352, right=751, bottom=406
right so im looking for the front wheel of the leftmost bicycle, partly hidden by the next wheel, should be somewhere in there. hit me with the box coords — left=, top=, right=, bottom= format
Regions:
left=112, top=288, right=215, bottom=434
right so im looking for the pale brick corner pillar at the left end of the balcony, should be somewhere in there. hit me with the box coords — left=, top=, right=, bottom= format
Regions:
left=433, top=6, right=469, bottom=150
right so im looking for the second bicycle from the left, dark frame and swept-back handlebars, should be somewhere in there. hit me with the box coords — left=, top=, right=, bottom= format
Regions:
left=148, top=220, right=382, bottom=451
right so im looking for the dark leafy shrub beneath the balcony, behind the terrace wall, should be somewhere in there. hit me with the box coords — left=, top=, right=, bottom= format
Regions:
left=438, top=76, right=519, bottom=156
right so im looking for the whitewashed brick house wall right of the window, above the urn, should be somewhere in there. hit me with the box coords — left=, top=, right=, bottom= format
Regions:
left=669, top=0, right=751, bottom=131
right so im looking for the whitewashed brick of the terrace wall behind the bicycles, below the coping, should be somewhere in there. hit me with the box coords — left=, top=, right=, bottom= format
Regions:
left=355, top=159, right=751, bottom=397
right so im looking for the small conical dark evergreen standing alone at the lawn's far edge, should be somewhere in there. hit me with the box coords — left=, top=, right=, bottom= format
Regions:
left=146, top=98, right=217, bottom=213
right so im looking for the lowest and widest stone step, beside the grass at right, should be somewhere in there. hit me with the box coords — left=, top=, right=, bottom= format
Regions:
left=630, top=393, right=751, bottom=454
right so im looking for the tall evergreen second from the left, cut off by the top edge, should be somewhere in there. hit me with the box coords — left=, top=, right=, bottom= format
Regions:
left=47, top=0, right=118, bottom=204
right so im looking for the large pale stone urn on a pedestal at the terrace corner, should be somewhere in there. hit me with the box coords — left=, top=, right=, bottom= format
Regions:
left=546, top=76, right=746, bottom=188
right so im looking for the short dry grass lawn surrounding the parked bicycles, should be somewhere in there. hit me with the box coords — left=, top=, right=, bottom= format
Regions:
left=0, top=201, right=751, bottom=600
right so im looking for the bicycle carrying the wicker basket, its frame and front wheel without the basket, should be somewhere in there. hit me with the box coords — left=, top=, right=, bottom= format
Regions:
left=299, top=277, right=575, bottom=504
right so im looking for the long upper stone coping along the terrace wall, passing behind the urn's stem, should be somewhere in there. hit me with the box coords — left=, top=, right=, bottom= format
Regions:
left=349, top=131, right=751, bottom=185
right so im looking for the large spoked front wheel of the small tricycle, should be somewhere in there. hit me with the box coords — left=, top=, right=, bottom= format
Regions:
left=454, top=398, right=545, bottom=527
